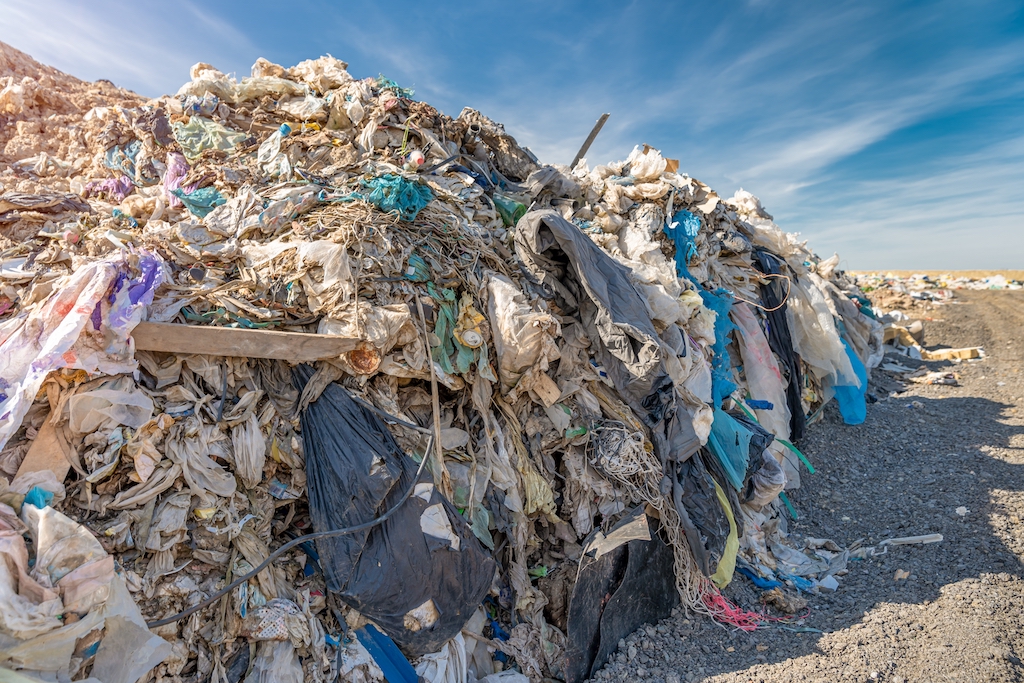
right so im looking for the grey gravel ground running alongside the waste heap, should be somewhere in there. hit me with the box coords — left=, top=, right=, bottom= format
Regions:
left=596, top=291, right=1024, bottom=683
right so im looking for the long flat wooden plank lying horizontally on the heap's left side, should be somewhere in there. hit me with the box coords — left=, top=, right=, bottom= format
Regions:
left=131, top=323, right=358, bottom=362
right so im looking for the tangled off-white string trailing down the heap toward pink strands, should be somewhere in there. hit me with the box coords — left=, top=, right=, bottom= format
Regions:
left=588, top=421, right=763, bottom=631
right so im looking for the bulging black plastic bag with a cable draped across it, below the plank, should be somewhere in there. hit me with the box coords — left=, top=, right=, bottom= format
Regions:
left=293, top=366, right=496, bottom=655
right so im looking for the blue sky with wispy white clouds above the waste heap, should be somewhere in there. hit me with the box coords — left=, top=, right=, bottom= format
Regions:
left=0, top=0, right=1024, bottom=269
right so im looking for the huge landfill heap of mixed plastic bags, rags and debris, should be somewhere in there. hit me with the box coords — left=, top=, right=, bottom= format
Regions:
left=0, top=44, right=884, bottom=683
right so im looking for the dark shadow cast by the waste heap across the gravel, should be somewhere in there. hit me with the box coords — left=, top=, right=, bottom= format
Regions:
left=665, top=396, right=1024, bottom=680
